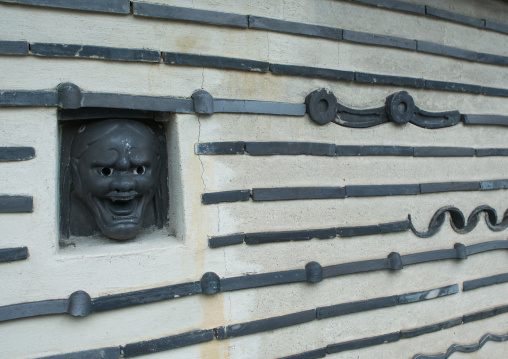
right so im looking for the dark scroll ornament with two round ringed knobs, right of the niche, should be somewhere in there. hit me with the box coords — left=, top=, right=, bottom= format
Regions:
left=305, top=89, right=460, bottom=128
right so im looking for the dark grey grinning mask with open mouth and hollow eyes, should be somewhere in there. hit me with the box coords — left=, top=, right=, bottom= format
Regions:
left=71, top=119, right=160, bottom=240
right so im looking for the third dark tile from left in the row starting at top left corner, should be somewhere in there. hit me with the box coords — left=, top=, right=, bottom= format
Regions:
left=249, top=15, right=343, bottom=40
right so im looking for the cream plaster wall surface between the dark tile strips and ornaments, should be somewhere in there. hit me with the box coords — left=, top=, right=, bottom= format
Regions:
left=0, top=0, right=508, bottom=358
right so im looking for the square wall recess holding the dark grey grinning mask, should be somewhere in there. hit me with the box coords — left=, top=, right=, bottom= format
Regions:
left=59, top=108, right=171, bottom=249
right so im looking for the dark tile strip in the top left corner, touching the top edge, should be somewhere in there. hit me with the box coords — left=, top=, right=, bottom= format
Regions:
left=0, top=0, right=131, bottom=14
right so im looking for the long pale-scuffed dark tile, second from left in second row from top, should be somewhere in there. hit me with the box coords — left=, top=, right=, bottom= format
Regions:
left=30, top=42, right=161, bottom=62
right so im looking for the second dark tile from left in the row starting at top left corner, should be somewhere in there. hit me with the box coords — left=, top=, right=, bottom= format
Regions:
left=132, top=1, right=249, bottom=28
